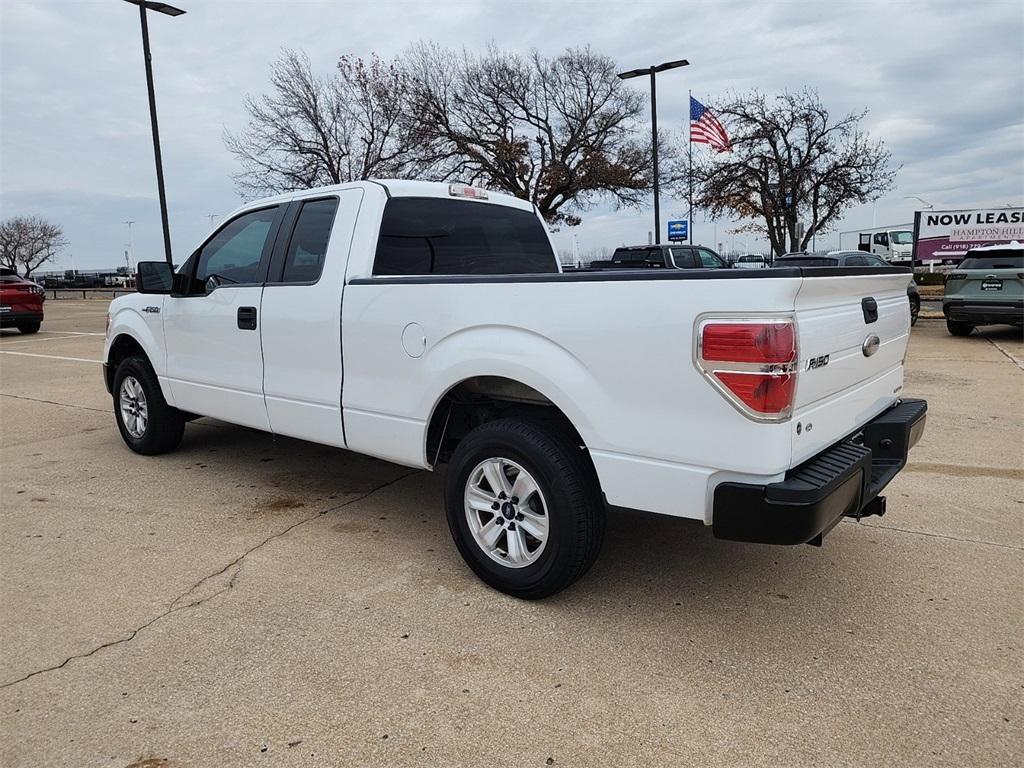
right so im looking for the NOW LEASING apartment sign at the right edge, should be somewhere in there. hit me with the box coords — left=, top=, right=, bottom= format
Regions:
left=913, top=208, right=1024, bottom=262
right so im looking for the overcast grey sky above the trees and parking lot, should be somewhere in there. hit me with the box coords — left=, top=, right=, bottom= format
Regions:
left=0, top=0, right=1024, bottom=269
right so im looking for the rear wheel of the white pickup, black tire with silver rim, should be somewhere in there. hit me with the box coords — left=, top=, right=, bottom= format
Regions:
left=445, top=419, right=604, bottom=600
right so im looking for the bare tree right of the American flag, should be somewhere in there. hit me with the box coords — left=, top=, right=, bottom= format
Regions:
left=676, top=89, right=898, bottom=255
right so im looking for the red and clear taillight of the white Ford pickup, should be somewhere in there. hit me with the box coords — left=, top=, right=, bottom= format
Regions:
left=696, top=319, right=797, bottom=421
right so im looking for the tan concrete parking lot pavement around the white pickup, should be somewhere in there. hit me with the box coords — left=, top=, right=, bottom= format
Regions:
left=0, top=301, right=1024, bottom=768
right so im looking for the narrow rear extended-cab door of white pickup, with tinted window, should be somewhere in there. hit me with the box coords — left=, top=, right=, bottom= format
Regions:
left=260, top=189, right=362, bottom=446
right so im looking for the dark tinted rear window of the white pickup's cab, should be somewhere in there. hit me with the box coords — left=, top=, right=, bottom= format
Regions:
left=374, top=198, right=558, bottom=274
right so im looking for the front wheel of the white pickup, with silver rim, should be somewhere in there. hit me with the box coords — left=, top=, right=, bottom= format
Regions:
left=114, top=356, right=185, bottom=456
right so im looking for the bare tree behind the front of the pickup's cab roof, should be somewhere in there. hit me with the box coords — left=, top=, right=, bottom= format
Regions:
left=224, top=50, right=428, bottom=195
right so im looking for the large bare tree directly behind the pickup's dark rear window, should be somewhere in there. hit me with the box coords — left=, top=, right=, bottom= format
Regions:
left=402, top=43, right=651, bottom=225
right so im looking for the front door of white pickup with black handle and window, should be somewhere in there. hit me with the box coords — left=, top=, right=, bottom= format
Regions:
left=164, top=206, right=284, bottom=429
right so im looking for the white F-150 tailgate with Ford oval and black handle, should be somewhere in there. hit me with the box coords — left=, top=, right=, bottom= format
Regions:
left=793, top=272, right=910, bottom=462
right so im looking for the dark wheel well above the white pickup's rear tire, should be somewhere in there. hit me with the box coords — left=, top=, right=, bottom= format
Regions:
left=426, top=376, right=586, bottom=466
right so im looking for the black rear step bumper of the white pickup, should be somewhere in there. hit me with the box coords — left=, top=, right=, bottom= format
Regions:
left=712, top=399, right=928, bottom=544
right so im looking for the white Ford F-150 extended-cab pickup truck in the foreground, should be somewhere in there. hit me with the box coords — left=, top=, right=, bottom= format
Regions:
left=104, top=181, right=927, bottom=598
